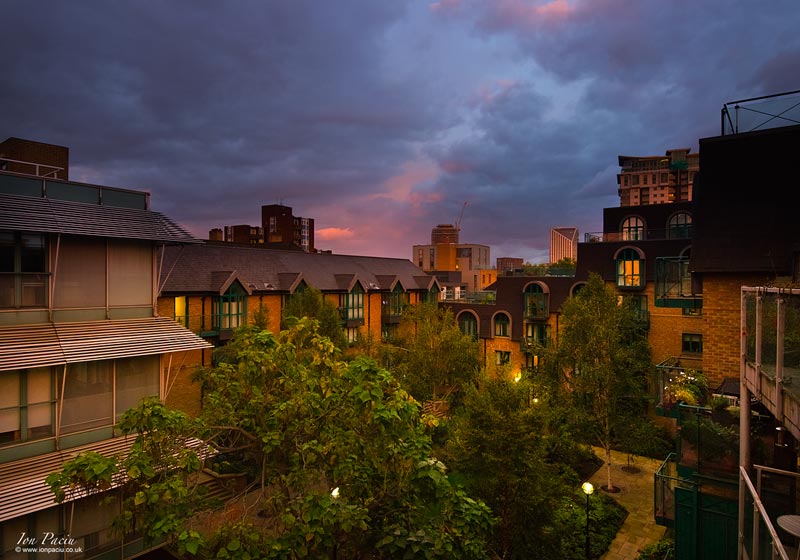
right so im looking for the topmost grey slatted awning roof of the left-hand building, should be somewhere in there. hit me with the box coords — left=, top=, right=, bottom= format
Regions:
left=0, top=194, right=199, bottom=243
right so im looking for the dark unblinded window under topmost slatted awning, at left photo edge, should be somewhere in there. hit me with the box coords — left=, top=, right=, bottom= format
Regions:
left=0, top=231, right=48, bottom=308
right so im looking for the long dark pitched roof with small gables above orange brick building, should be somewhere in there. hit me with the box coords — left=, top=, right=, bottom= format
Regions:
left=161, top=243, right=438, bottom=293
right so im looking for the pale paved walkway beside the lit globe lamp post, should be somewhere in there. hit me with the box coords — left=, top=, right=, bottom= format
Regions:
left=589, top=447, right=667, bottom=560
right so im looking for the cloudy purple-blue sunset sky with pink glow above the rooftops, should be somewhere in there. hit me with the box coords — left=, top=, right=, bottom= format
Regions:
left=0, top=0, right=800, bottom=263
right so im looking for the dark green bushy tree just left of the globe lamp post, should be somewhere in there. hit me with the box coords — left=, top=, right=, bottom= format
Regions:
left=445, top=379, right=579, bottom=560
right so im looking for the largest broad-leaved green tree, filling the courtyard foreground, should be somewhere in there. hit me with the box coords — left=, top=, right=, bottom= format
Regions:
left=50, top=318, right=492, bottom=559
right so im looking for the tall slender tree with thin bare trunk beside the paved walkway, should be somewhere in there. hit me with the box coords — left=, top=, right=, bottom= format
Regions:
left=548, top=273, right=651, bottom=490
